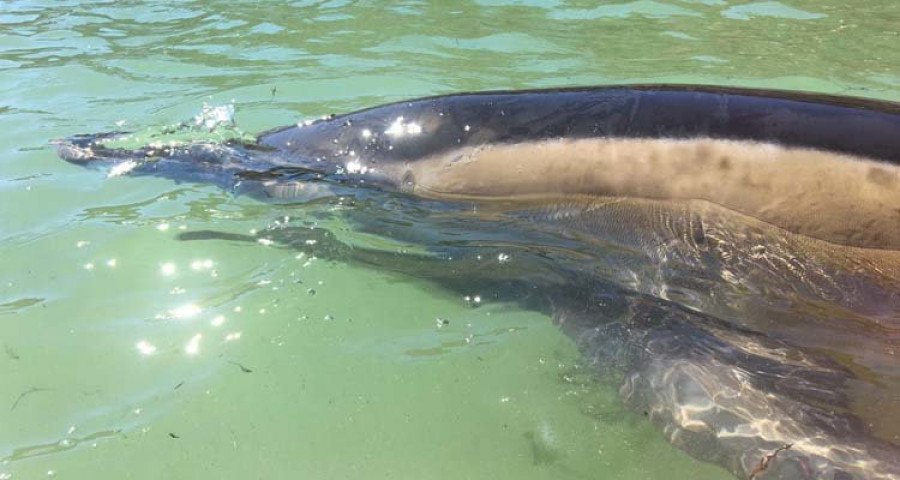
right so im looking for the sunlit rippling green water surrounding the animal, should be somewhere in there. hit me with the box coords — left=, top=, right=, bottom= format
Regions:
left=0, top=0, right=900, bottom=480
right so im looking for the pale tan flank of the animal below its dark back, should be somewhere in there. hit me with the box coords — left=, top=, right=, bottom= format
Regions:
left=402, top=135, right=900, bottom=249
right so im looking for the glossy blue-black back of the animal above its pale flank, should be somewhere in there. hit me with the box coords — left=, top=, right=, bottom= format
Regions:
left=259, top=85, right=900, bottom=164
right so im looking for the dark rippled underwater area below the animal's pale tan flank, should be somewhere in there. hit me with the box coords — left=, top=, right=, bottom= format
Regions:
left=180, top=191, right=900, bottom=478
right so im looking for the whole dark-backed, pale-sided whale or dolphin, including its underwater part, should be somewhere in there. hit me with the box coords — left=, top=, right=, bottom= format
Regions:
left=58, top=86, right=900, bottom=479
